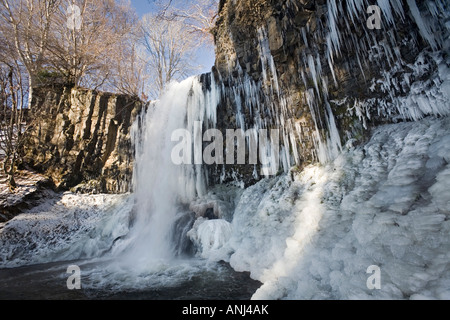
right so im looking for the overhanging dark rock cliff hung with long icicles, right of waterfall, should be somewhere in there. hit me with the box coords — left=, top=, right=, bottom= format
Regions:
left=213, top=0, right=450, bottom=184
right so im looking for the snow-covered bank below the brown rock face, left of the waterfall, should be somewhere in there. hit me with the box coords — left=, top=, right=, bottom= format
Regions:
left=0, top=193, right=134, bottom=268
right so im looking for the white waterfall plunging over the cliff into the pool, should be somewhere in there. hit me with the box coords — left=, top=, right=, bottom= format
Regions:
left=116, top=74, right=218, bottom=265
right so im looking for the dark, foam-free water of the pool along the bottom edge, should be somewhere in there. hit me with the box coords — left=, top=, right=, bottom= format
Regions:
left=0, top=262, right=261, bottom=300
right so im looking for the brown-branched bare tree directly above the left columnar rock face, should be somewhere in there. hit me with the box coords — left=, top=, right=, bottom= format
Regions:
left=48, top=0, right=137, bottom=88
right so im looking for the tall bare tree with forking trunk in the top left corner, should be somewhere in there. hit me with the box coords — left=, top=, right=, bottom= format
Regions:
left=0, top=0, right=60, bottom=106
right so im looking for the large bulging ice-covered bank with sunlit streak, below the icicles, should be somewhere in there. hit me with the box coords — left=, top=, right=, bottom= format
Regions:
left=193, top=118, right=450, bottom=299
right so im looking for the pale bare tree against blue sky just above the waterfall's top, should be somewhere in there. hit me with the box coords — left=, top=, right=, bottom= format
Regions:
left=141, top=14, right=199, bottom=97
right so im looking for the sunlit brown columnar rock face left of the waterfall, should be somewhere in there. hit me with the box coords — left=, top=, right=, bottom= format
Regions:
left=24, top=86, right=143, bottom=193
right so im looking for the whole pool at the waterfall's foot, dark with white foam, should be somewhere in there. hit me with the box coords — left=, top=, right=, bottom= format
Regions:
left=0, top=259, right=261, bottom=300
